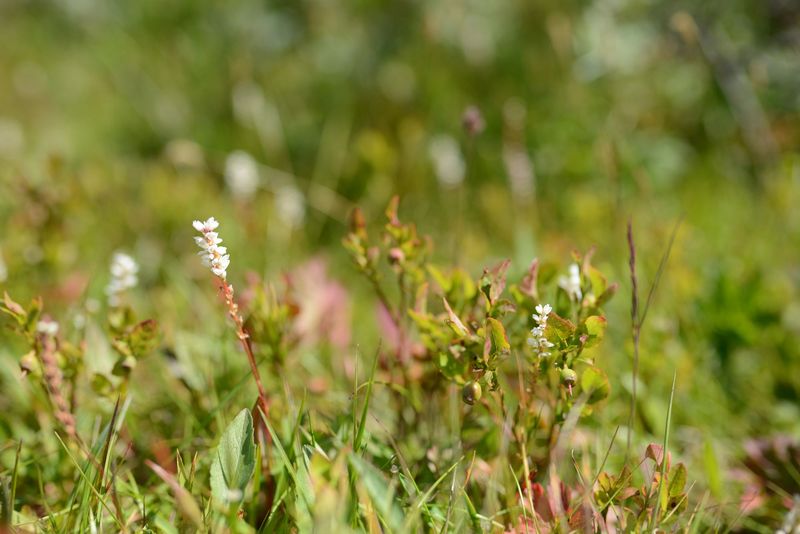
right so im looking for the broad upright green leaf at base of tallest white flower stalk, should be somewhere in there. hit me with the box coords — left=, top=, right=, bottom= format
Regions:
left=211, top=409, right=256, bottom=503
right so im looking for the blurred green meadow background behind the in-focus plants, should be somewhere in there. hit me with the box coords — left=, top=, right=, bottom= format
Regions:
left=0, top=0, right=800, bottom=524
